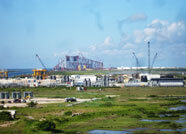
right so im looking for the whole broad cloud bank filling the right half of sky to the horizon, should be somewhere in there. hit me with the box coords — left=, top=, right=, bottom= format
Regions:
left=88, top=19, right=186, bottom=66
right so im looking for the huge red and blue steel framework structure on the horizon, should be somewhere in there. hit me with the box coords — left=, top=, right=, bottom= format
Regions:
left=53, top=56, right=103, bottom=71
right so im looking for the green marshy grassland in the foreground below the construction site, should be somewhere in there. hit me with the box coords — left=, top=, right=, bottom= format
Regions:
left=0, top=87, right=186, bottom=134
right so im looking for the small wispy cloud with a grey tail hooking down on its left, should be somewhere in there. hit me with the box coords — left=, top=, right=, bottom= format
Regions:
left=118, top=13, right=147, bottom=36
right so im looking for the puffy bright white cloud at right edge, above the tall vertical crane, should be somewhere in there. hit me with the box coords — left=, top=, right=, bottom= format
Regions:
left=142, top=20, right=186, bottom=44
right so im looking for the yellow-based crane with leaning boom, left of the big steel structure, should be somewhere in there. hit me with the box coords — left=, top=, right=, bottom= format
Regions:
left=32, top=54, right=48, bottom=79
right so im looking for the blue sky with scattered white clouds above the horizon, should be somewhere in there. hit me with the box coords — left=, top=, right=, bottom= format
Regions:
left=0, top=0, right=186, bottom=69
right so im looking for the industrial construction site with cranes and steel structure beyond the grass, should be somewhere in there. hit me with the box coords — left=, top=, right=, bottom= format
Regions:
left=0, top=42, right=185, bottom=88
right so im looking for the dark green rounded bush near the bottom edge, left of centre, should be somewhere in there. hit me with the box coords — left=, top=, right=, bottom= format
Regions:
left=37, top=120, right=56, bottom=131
